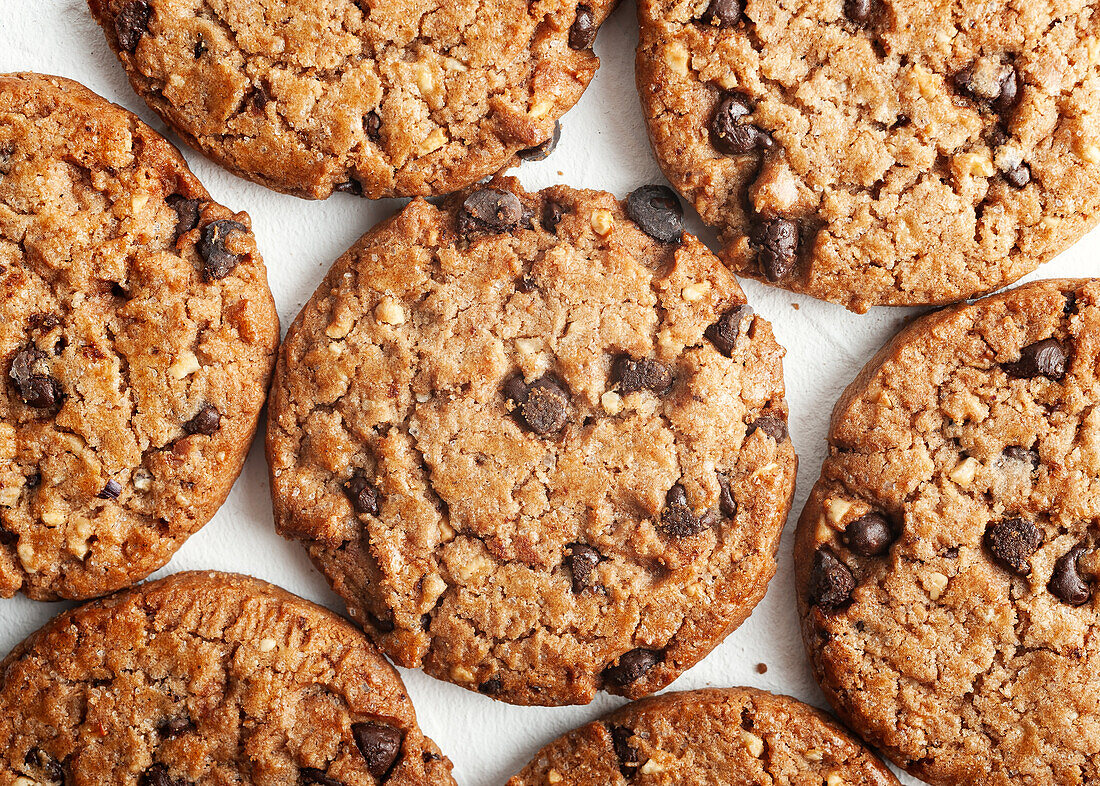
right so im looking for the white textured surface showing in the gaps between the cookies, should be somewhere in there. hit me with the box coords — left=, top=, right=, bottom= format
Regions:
left=0, top=0, right=1100, bottom=786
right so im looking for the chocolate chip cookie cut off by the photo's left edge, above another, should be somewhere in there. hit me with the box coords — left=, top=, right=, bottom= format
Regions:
left=0, top=74, right=278, bottom=600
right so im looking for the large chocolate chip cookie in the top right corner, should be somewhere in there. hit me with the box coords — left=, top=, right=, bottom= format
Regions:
left=637, top=0, right=1100, bottom=312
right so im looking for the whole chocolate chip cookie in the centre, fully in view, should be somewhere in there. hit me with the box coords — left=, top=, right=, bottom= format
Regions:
left=267, top=179, right=796, bottom=705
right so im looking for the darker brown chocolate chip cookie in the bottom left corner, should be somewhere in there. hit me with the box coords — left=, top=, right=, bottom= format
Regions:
left=0, top=573, right=454, bottom=786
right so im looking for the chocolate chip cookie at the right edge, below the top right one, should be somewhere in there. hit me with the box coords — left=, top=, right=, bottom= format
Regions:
left=795, top=279, right=1100, bottom=786
